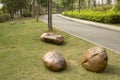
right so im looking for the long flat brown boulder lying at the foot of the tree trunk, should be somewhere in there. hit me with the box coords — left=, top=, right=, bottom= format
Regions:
left=41, top=33, right=64, bottom=44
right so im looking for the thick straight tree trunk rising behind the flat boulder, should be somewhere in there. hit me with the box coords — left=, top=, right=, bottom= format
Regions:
left=48, top=0, right=52, bottom=31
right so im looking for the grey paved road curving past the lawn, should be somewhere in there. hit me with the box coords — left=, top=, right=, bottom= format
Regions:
left=41, top=14, right=120, bottom=53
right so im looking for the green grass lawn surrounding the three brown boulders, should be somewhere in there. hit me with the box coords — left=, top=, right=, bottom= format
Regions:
left=0, top=18, right=120, bottom=80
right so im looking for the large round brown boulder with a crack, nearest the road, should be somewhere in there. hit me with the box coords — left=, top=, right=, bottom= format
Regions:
left=82, top=46, right=108, bottom=72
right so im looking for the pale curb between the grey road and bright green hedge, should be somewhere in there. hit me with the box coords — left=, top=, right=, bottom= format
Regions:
left=59, top=14, right=120, bottom=31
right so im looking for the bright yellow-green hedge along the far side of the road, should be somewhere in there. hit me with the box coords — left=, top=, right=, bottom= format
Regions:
left=62, top=10, right=120, bottom=23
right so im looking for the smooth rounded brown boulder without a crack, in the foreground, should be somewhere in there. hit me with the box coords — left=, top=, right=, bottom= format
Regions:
left=42, top=51, right=66, bottom=71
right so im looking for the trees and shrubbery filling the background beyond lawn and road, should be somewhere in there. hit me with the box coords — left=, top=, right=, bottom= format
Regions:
left=0, top=0, right=120, bottom=23
